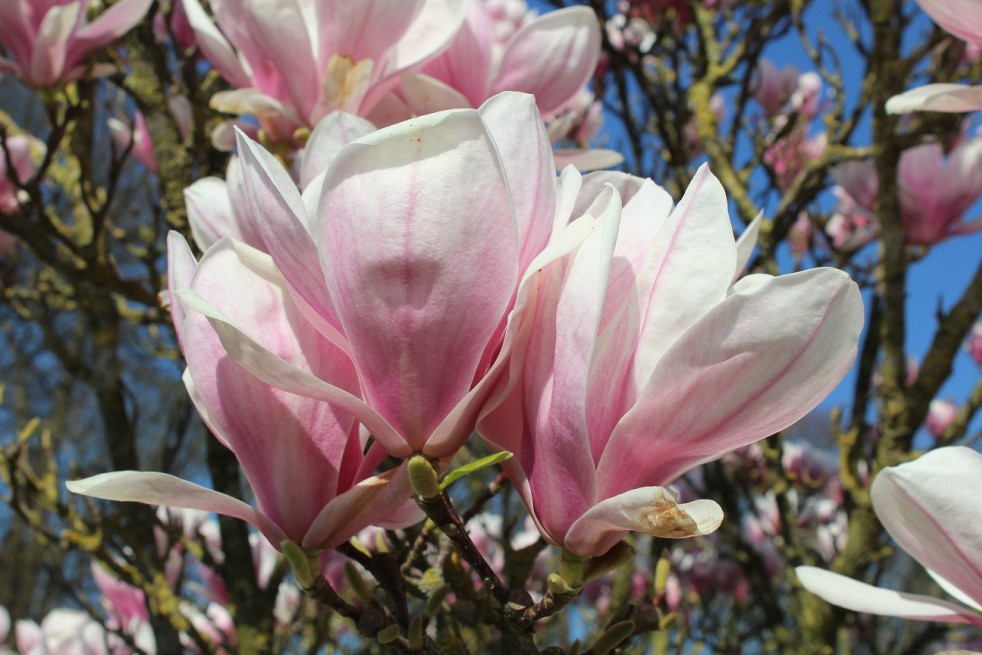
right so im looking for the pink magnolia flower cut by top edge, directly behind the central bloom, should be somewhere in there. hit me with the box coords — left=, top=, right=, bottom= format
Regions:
left=184, top=0, right=465, bottom=140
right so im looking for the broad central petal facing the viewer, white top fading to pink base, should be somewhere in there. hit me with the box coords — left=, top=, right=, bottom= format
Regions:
left=315, top=110, right=518, bottom=450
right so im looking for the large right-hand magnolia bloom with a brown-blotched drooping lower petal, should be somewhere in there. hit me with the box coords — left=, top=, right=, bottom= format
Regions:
left=478, top=166, right=863, bottom=556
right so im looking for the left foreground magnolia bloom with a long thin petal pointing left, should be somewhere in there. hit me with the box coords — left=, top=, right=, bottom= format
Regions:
left=68, top=233, right=417, bottom=549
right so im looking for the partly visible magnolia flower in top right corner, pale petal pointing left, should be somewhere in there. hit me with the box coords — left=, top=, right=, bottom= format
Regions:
left=886, top=0, right=982, bottom=114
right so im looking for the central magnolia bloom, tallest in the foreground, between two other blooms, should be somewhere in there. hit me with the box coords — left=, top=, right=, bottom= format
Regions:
left=174, top=93, right=579, bottom=457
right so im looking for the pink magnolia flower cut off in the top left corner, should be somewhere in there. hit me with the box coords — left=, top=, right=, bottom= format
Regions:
left=0, top=0, right=151, bottom=87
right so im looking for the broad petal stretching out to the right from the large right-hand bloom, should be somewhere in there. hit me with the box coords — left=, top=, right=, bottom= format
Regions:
left=599, top=269, right=863, bottom=498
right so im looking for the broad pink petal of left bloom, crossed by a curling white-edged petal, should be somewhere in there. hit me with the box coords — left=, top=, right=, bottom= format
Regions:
left=175, top=239, right=362, bottom=541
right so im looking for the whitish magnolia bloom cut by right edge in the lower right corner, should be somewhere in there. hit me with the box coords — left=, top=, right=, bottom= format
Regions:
left=795, top=446, right=982, bottom=628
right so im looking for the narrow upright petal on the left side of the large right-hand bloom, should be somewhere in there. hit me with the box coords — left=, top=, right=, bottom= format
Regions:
left=480, top=188, right=620, bottom=543
